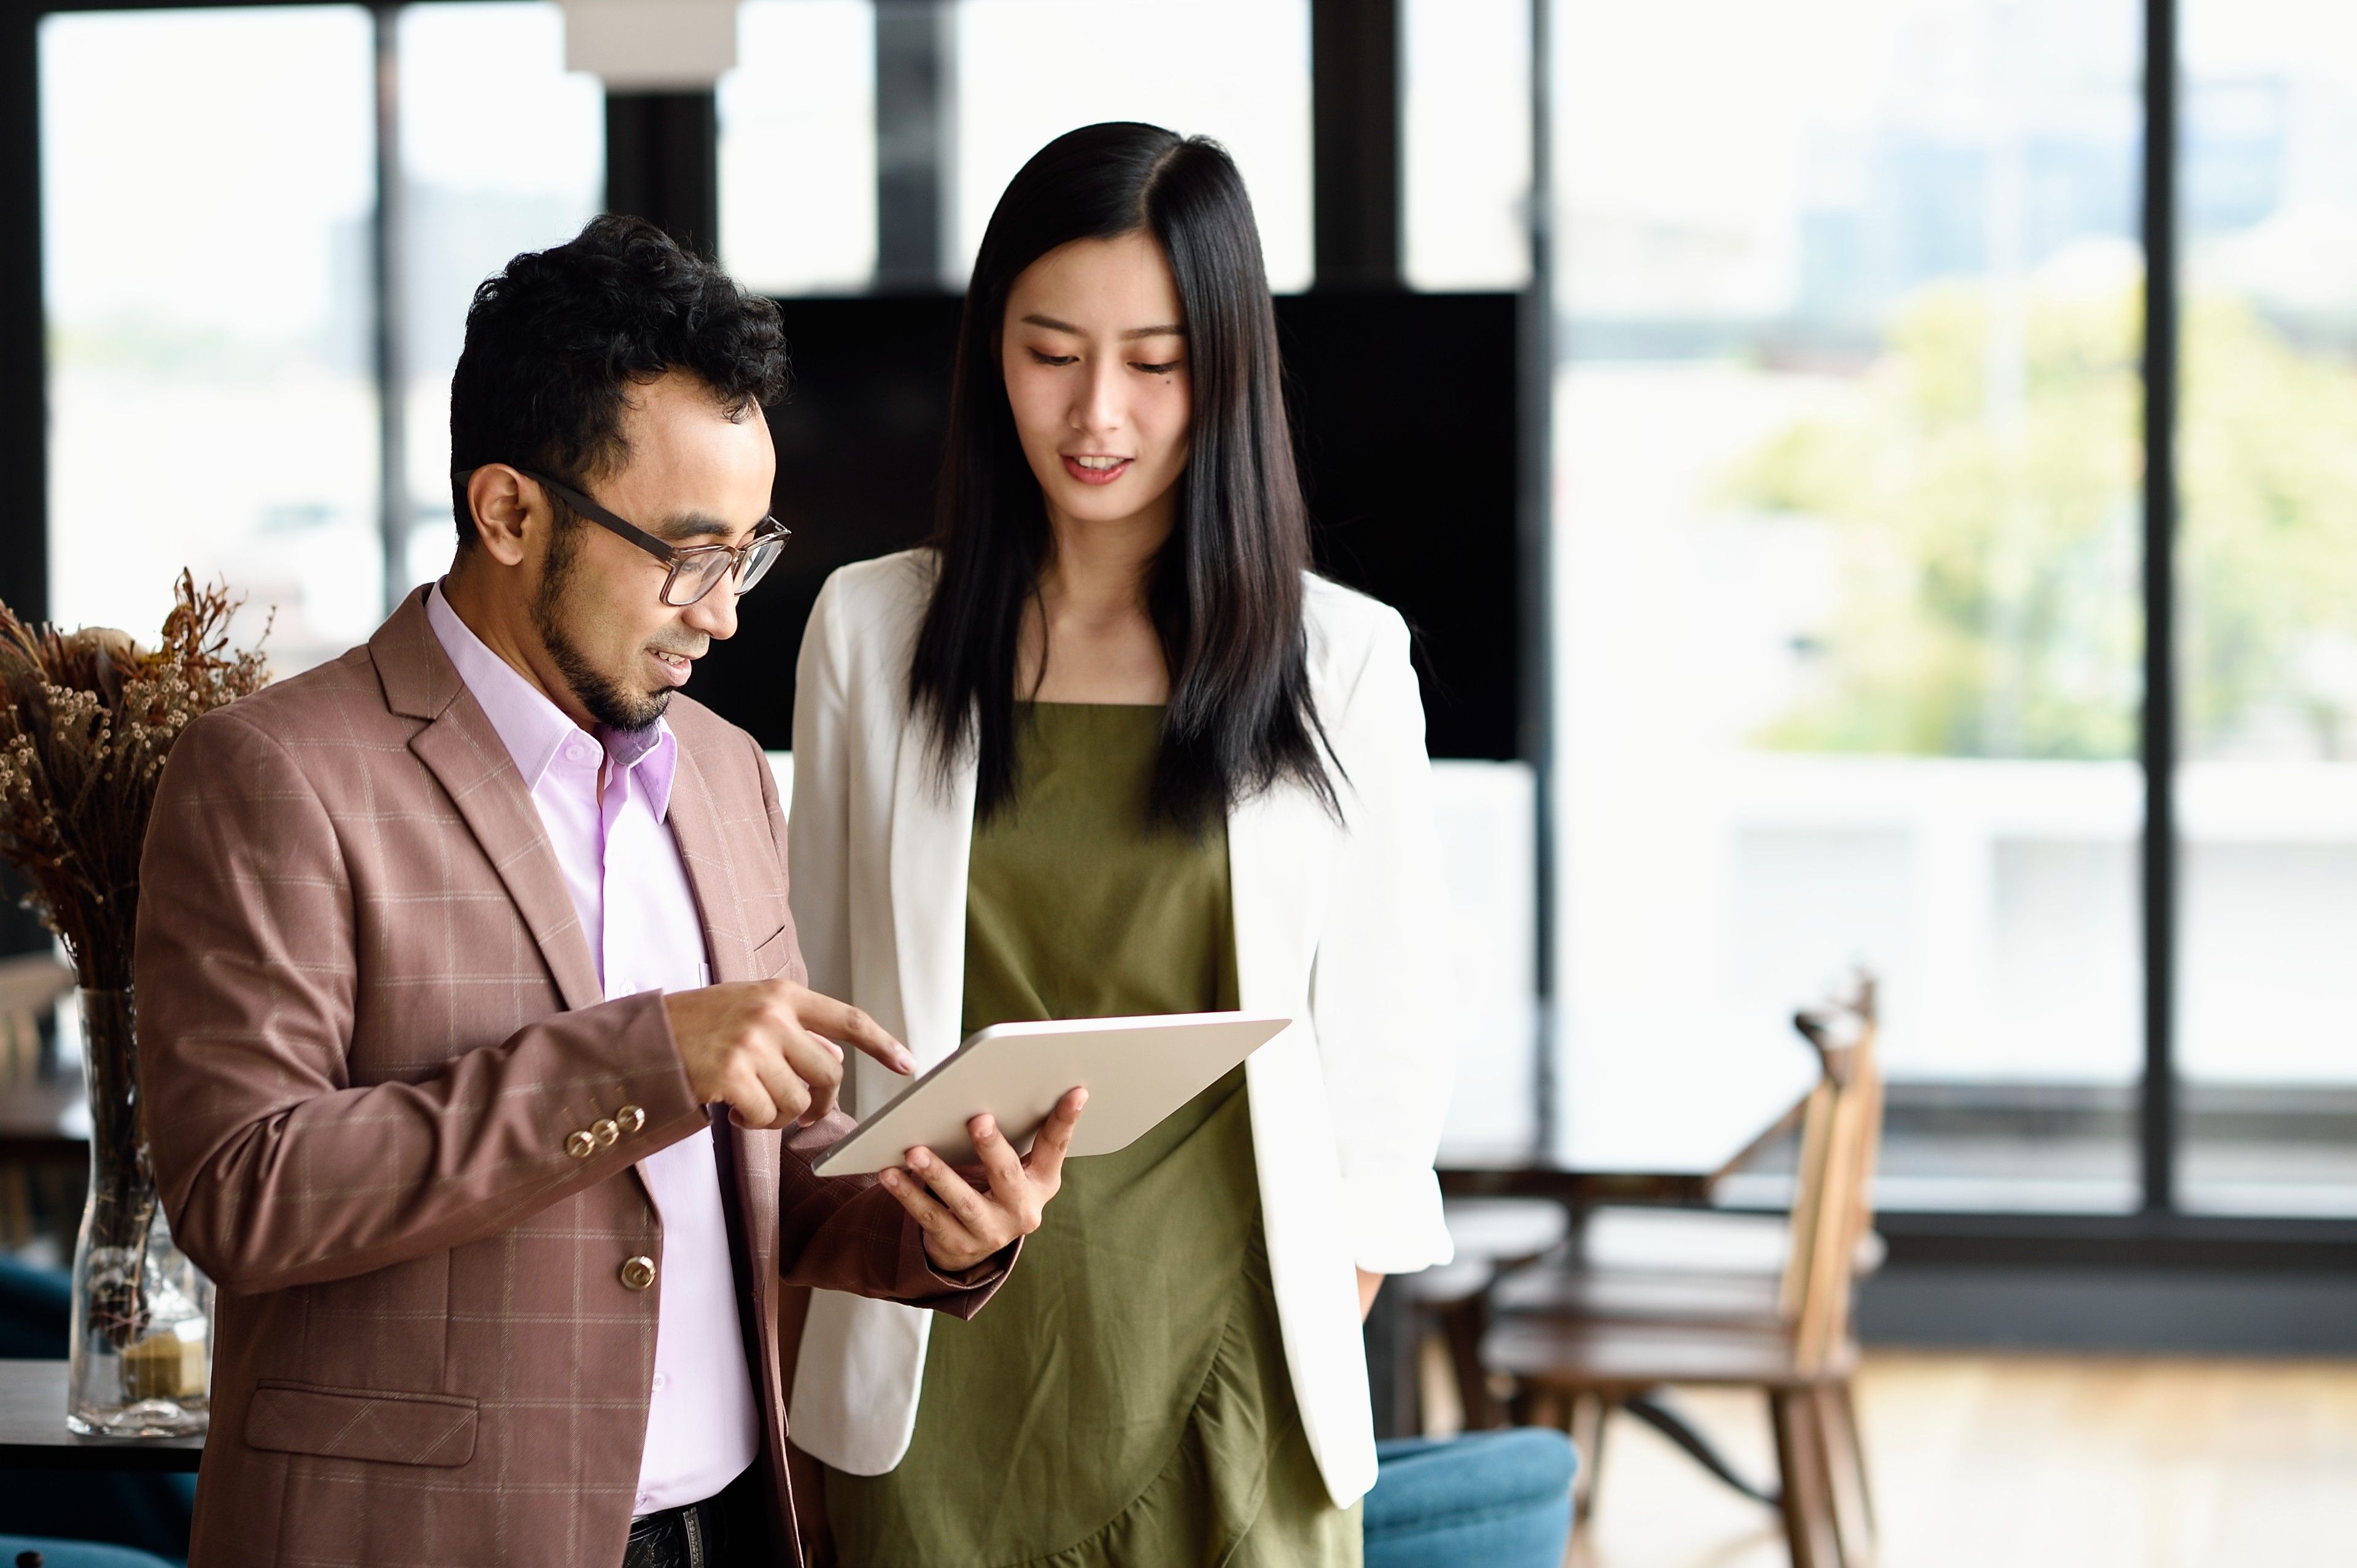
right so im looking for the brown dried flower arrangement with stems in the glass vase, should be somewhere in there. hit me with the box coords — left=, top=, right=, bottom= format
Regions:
left=0, top=571, right=269, bottom=1351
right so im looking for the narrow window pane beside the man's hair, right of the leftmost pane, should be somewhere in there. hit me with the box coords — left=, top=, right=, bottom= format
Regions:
left=396, top=0, right=606, bottom=592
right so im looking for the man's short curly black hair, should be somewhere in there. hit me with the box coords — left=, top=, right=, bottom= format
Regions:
left=450, top=215, right=785, bottom=547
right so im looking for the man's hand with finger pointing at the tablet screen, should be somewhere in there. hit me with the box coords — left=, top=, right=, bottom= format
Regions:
left=662, top=981, right=917, bottom=1129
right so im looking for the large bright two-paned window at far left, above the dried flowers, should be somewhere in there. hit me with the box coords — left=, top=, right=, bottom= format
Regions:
left=40, top=2, right=603, bottom=672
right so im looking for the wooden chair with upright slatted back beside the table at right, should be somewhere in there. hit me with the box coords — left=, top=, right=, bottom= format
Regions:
left=1480, top=978, right=1881, bottom=1568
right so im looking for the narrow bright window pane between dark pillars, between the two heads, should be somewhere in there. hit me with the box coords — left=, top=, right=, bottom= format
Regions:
left=719, top=0, right=877, bottom=295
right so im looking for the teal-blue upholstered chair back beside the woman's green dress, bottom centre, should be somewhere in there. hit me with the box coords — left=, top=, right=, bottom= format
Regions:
left=1367, top=1426, right=1579, bottom=1568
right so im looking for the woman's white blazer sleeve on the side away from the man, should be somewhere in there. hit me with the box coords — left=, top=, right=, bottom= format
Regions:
left=1310, top=608, right=1457, bottom=1273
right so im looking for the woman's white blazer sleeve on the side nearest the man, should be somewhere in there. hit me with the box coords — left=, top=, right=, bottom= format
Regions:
left=785, top=577, right=851, bottom=1014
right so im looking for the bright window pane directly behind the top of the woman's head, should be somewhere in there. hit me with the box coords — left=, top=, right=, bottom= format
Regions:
left=950, top=0, right=1310, bottom=292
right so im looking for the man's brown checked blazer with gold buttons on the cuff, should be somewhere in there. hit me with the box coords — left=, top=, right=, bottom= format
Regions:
left=137, top=592, right=1004, bottom=1568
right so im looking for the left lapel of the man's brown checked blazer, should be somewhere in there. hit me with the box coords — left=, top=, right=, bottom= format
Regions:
left=368, top=590, right=603, bottom=1009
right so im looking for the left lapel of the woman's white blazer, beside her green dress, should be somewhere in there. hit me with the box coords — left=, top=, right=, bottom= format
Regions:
left=889, top=719, right=976, bottom=1070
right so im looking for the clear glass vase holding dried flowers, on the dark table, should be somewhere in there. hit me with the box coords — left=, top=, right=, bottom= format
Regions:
left=66, top=986, right=212, bottom=1439
